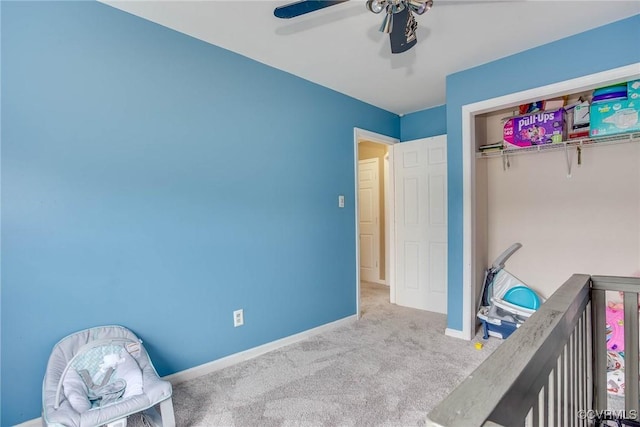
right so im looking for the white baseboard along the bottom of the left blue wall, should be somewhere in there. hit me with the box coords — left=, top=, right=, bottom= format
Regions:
left=15, top=314, right=358, bottom=427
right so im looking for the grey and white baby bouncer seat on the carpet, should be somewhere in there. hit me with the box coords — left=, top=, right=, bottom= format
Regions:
left=42, top=326, right=175, bottom=427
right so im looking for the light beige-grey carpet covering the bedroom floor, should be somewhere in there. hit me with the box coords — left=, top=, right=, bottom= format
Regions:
left=129, top=282, right=501, bottom=427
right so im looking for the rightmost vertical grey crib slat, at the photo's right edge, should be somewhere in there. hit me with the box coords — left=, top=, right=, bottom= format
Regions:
left=624, top=292, right=639, bottom=419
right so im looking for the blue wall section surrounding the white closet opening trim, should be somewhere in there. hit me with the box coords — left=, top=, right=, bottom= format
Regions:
left=447, top=15, right=640, bottom=330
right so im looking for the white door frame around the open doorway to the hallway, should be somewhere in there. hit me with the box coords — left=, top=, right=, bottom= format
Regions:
left=353, top=127, right=400, bottom=319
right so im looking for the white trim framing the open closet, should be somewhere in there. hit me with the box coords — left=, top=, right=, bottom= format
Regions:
left=458, top=62, right=640, bottom=340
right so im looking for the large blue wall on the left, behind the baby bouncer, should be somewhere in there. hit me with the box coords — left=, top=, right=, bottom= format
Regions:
left=1, top=1, right=400, bottom=426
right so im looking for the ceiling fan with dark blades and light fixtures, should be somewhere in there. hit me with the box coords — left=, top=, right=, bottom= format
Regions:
left=273, top=0, right=433, bottom=53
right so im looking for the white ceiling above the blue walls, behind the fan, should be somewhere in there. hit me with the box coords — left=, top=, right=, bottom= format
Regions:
left=105, top=0, right=640, bottom=114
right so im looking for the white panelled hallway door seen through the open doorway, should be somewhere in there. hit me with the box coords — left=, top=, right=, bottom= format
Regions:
left=358, top=158, right=380, bottom=282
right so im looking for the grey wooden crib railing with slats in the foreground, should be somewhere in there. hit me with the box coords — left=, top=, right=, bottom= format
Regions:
left=427, top=274, right=640, bottom=427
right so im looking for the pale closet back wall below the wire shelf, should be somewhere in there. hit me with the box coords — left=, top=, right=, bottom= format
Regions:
left=479, top=142, right=640, bottom=297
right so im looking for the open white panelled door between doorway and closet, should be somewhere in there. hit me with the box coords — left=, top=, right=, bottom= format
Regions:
left=394, top=135, right=447, bottom=313
